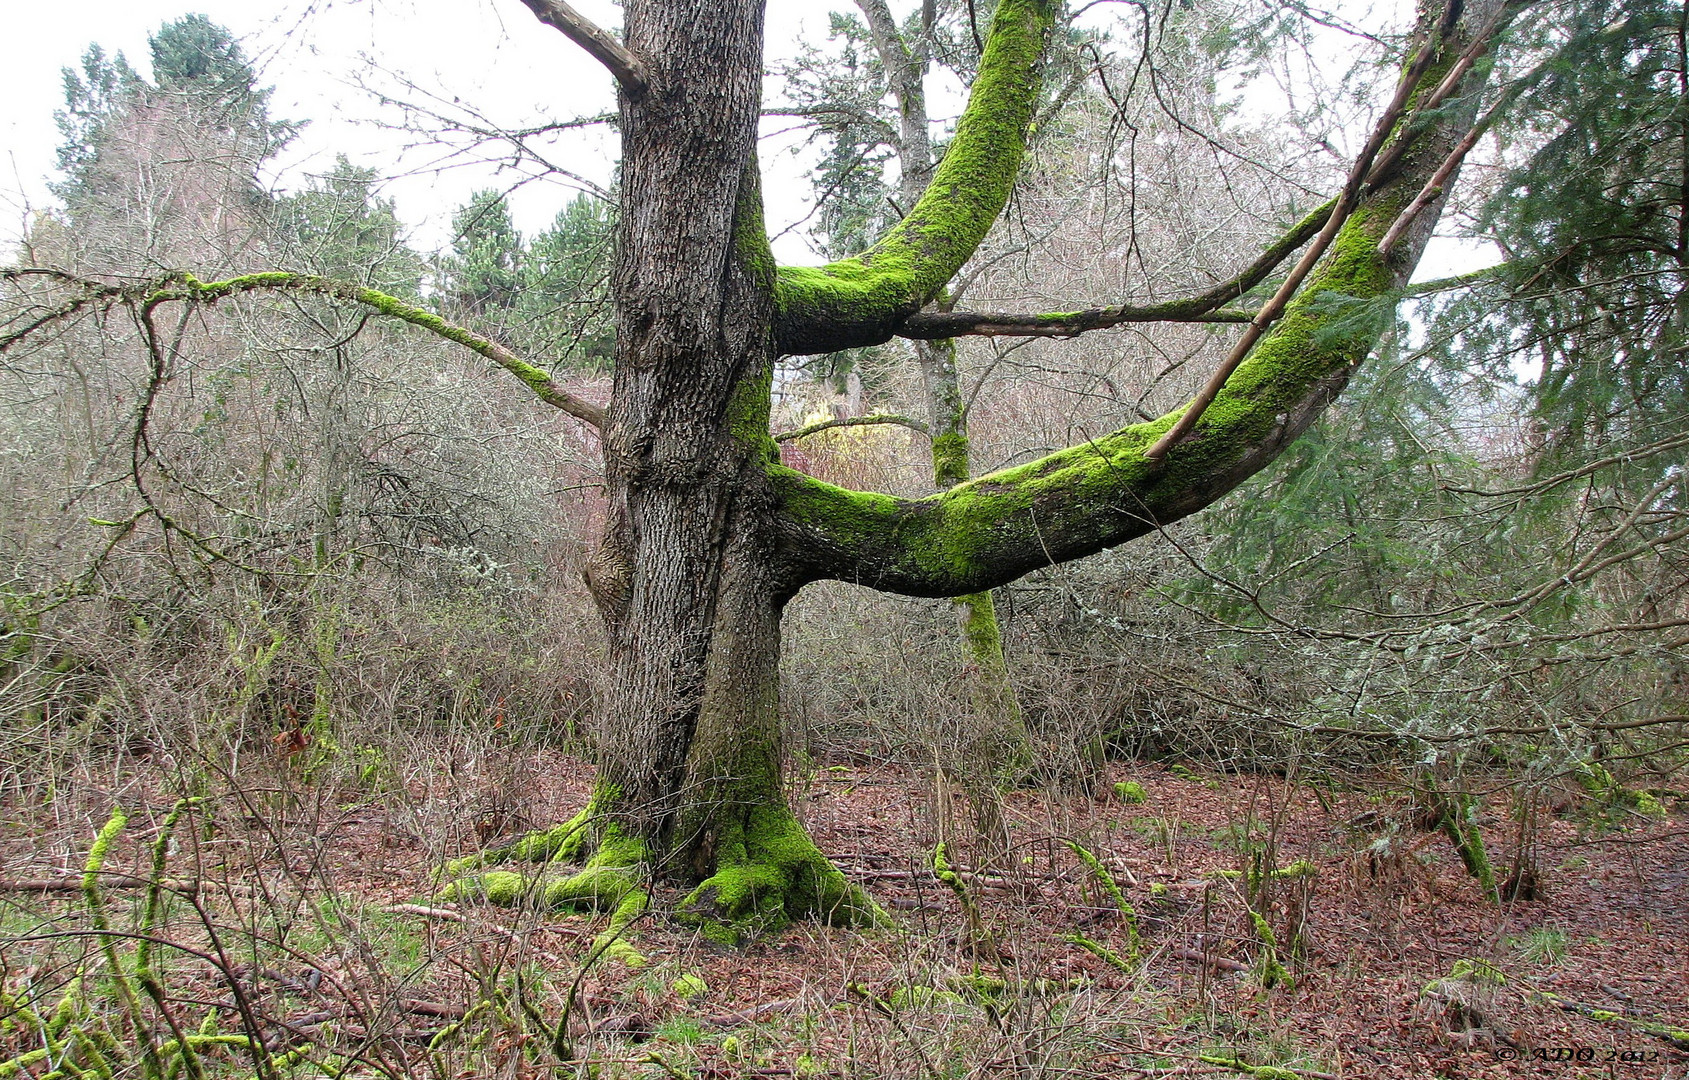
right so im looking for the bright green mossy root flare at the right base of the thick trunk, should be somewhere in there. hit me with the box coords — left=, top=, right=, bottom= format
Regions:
left=677, top=806, right=890, bottom=945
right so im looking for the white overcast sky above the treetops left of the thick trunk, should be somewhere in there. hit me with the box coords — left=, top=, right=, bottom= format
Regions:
left=0, top=0, right=844, bottom=257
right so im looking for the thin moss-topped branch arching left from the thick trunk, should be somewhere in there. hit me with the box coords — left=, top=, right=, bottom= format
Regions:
left=0, top=269, right=605, bottom=426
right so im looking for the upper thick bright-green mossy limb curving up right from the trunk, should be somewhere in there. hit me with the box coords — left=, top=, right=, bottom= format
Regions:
left=775, top=0, right=1056, bottom=355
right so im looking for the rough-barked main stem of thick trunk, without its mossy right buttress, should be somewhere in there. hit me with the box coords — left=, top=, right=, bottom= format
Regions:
left=588, top=0, right=772, bottom=847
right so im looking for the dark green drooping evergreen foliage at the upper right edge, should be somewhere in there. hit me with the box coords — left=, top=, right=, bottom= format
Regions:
left=1441, top=0, right=1689, bottom=468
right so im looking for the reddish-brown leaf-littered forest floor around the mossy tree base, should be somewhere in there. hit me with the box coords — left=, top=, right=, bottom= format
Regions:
left=0, top=754, right=1689, bottom=1080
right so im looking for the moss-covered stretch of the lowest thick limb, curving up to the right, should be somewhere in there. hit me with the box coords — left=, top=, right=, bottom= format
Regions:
left=770, top=199, right=1398, bottom=597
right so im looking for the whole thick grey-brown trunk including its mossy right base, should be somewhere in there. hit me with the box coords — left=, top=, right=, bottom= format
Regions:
left=567, top=0, right=873, bottom=936
